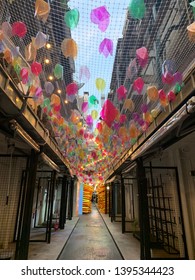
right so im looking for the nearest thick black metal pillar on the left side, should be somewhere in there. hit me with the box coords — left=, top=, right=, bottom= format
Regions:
left=15, top=150, right=38, bottom=260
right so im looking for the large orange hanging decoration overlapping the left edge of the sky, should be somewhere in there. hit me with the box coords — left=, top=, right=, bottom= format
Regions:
left=61, top=38, right=78, bottom=59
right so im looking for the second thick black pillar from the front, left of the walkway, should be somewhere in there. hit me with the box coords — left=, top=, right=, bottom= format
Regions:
left=59, top=176, right=68, bottom=229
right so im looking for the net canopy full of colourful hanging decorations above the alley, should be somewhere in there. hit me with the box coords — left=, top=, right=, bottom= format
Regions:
left=0, top=0, right=195, bottom=184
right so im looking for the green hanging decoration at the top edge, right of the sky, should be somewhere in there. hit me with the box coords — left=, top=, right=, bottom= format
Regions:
left=128, top=0, right=146, bottom=19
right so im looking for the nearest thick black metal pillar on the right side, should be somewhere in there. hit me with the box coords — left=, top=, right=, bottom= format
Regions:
left=137, top=158, right=151, bottom=260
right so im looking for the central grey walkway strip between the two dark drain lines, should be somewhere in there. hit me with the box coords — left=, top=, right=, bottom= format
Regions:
left=59, top=205, right=122, bottom=260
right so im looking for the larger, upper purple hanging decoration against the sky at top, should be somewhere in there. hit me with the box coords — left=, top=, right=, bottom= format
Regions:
left=90, top=6, right=110, bottom=32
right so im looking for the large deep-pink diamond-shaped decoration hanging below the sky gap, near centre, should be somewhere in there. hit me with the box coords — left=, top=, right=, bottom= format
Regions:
left=100, top=99, right=119, bottom=127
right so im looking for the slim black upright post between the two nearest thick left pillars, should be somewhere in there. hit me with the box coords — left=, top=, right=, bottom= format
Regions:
left=46, top=171, right=56, bottom=243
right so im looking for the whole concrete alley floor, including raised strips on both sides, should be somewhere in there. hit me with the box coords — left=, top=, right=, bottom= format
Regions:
left=28, top=205, right=140, bottom=260
